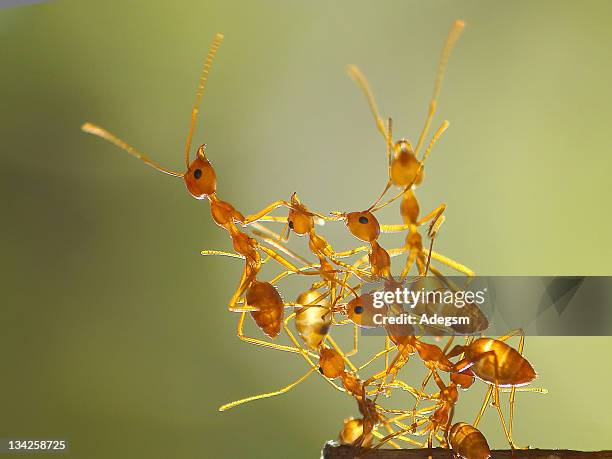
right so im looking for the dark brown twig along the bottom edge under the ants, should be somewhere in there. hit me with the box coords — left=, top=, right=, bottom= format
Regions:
left=321, top=442, right=612, bottom=459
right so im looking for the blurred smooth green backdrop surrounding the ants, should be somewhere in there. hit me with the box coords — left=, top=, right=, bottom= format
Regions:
left=0, top=0, right=612, bottom=458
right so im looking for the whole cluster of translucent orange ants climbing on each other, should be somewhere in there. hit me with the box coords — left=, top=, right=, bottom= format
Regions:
left=82, top=21, right=545, bottom=459
